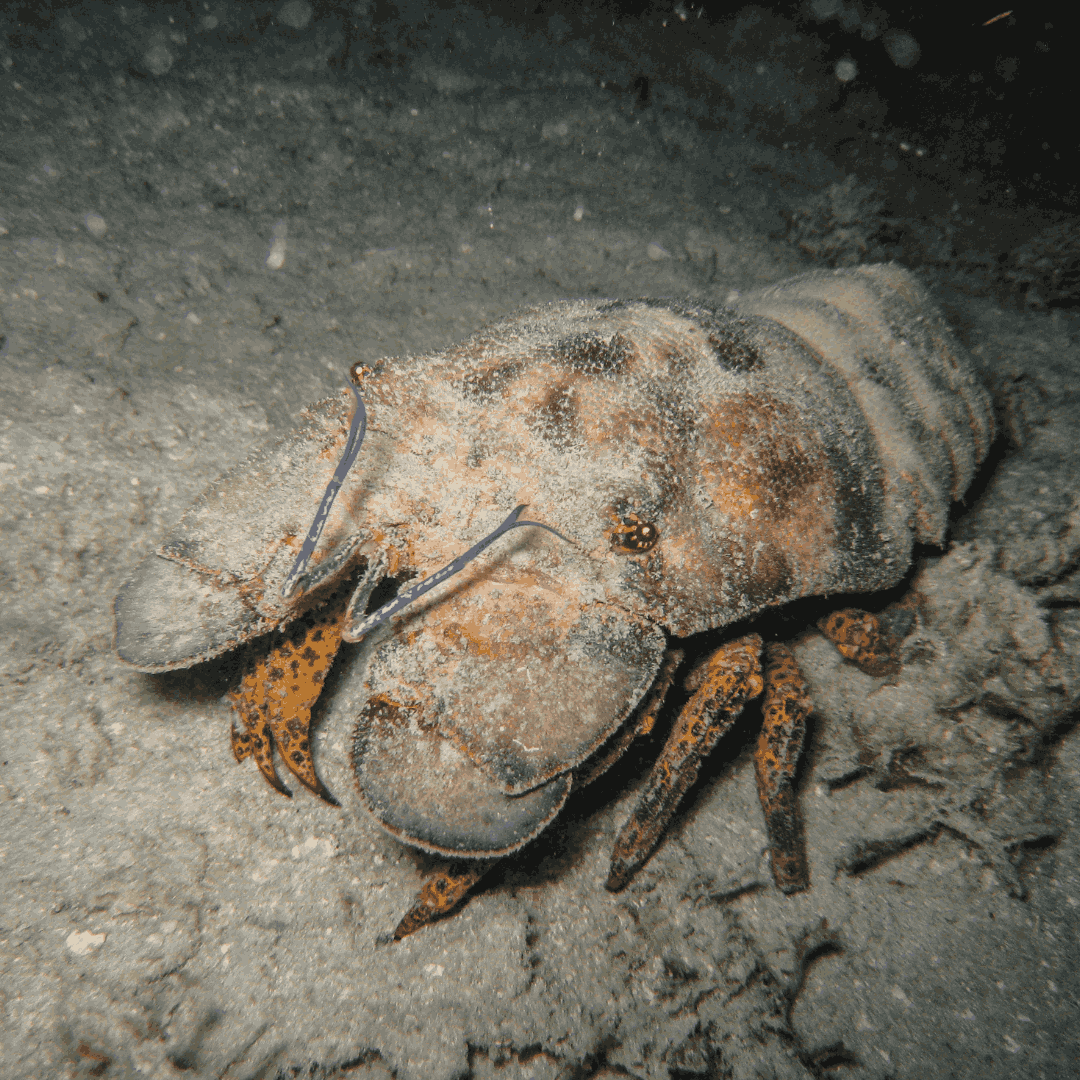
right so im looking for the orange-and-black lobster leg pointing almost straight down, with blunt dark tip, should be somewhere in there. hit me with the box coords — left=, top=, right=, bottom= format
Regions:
left=754, top=643, right=811, bottom=893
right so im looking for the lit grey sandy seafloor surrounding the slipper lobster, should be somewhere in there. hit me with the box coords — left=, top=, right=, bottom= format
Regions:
left=0, top=2, right=1080, bottom=1080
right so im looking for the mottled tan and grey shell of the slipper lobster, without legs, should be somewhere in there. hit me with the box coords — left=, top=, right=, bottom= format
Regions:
left=117, top=266, right=993, bottom=898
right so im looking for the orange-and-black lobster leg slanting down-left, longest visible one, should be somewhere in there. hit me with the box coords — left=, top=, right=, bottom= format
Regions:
left=606, top=634, right=761, bottom=892
